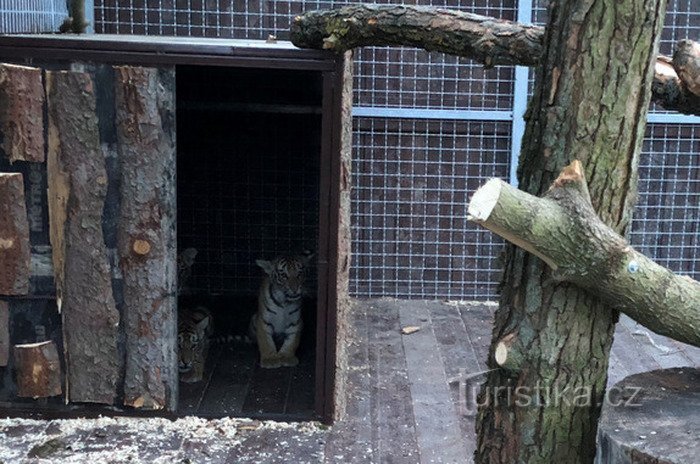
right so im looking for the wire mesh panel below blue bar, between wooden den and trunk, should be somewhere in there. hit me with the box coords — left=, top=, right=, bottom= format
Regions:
left=351, top=118, right=511, bottom=299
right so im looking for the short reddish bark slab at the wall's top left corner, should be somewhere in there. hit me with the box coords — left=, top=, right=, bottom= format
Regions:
left=0, top=64, right=44, bottom=163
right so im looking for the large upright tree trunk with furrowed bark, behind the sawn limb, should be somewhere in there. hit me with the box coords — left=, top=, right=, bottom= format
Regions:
left=476, top=0, right=665, bottom=463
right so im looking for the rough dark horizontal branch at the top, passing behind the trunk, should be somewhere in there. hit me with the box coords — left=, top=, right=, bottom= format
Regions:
left=291, top=5, right=700, bottom=115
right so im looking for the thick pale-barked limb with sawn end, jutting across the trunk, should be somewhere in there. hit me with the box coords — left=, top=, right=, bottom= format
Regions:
left=469, top=161, right=700, bottom=348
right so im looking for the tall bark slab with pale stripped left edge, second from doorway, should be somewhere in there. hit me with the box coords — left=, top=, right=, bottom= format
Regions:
left=46, top=71, right=122, bottom=404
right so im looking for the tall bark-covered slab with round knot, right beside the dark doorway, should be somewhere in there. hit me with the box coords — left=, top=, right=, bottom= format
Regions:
left=115, top=66, right=178, bottom=410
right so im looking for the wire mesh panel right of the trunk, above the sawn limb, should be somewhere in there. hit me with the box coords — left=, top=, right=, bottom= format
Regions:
left=630, top=124, right=700, bottom=279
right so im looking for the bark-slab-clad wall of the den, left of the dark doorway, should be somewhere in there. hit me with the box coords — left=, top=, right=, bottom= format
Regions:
left=0, top=59, right=178, bottom=410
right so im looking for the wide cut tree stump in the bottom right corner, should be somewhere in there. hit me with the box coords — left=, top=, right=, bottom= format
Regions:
left=596, top=367, right=700, bottom=464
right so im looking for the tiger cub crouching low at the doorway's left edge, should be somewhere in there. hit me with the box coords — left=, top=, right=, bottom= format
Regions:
left=177, top=306, right=214, bottom=383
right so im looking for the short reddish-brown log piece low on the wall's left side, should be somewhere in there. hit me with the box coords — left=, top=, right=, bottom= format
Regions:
left=14, top=341, right=63, bottom=398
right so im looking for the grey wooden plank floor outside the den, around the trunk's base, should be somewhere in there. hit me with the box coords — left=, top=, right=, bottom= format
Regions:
left=325, top=299, right=700, bottom=463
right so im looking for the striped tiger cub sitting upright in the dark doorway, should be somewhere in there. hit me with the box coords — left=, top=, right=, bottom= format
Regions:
left=249, top=251, right=314, bottom=369
